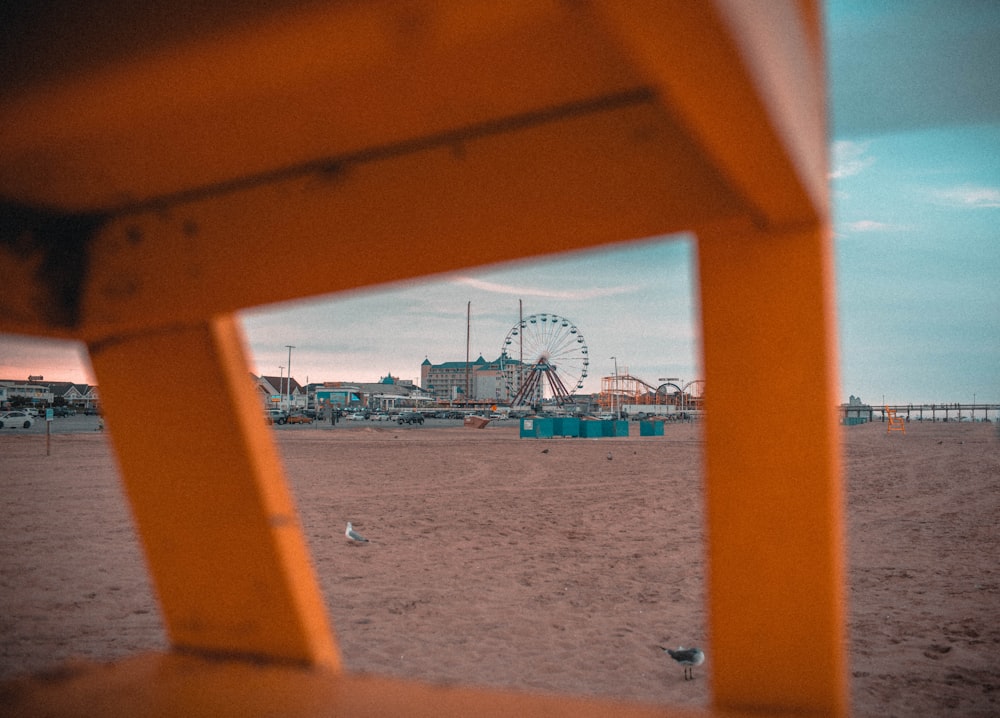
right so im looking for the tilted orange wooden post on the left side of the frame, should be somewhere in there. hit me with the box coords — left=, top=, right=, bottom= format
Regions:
left=89, top=315, right=339, bottom=668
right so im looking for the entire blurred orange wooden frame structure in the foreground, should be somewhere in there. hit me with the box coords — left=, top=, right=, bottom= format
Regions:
left=0, top=0, right=848, bottom=717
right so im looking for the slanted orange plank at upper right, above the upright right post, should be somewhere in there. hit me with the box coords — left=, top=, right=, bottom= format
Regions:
left=600, top=0, right=829, bottom=228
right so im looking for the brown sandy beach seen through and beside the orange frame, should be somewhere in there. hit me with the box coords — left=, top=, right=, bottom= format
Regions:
left=0, top=420, right=1000, bottom=717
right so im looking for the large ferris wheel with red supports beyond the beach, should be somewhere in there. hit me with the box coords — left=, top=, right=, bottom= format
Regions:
left=498, top=312, right=590, bottom=406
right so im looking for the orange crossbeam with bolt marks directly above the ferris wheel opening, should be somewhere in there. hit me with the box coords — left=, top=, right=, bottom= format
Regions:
left=66, top=98, right=741, bottom=338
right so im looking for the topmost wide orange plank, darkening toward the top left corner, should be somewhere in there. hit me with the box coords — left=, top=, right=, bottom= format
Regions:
left=0, top=0, right=641, bottom=212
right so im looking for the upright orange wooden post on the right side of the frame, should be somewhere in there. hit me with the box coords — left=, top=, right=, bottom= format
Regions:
left=698, top=222, right=848, bottom=715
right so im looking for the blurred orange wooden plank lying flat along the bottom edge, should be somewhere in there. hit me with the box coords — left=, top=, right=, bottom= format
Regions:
left=4, top=654, right=712, bottom=718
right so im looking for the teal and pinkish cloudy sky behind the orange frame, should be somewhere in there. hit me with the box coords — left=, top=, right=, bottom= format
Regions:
left=0, top=0, right=1000, bottom=404
